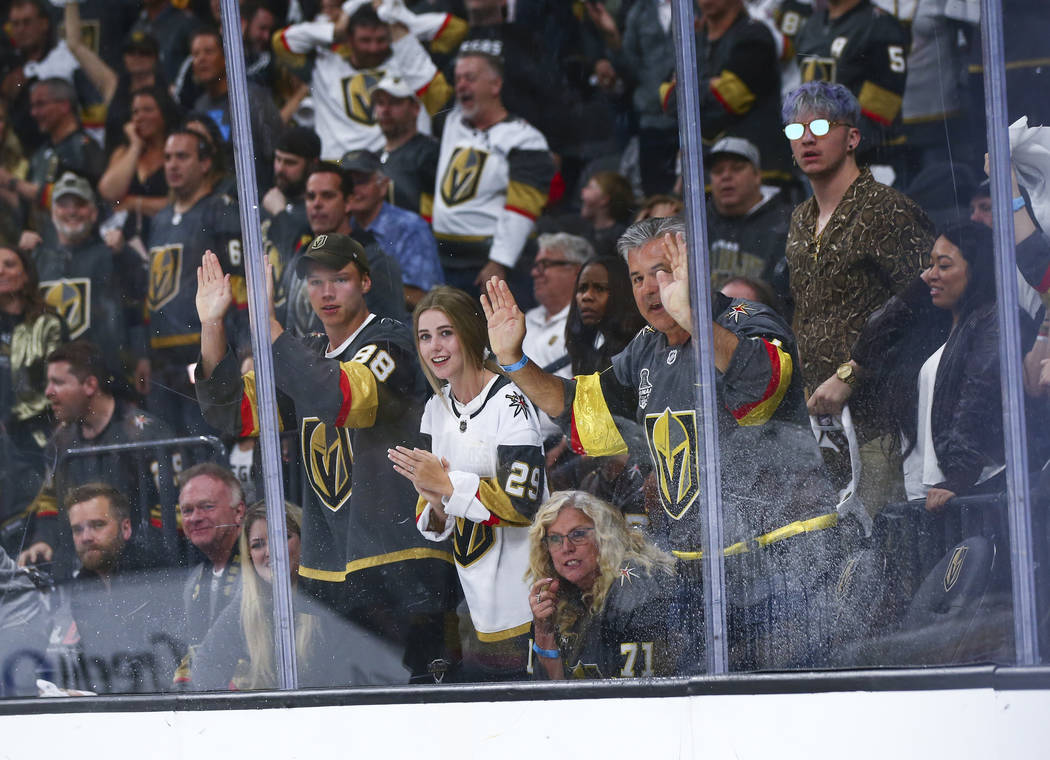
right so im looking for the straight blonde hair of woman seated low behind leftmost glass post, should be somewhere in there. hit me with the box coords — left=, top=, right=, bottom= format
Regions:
left=236, top=502, right=317, bottom=689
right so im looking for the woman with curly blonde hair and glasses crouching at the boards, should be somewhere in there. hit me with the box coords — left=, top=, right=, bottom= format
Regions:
left=526, top=491, right=680, bottom=680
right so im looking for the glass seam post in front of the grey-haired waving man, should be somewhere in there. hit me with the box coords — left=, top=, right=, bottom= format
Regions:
left=672, top=0, right=729, bottom=675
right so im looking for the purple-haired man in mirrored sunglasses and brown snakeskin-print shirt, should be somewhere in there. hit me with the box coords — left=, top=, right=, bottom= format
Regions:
left=783, top=82, right=933, bottom=493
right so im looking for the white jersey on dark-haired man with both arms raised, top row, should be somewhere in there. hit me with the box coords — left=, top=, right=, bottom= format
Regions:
left=278, top=20, right=449, bottom=161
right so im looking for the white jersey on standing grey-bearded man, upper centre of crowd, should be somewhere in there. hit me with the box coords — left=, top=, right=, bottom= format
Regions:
left=434, top=106, right=553, bottom=267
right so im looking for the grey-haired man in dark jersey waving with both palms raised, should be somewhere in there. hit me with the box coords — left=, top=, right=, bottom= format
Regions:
left=482, top=218, right=835, bottom=670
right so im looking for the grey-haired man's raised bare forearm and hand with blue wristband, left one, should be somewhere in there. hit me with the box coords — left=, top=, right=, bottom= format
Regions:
left=481, top=277, right=565, bottom=418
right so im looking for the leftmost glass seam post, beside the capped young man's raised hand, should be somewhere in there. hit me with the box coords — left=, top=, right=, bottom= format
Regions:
left=222, top=0, right=298, bottom=689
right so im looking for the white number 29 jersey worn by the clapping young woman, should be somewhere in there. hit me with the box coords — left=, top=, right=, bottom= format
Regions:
left=416, top=377, right=547, bottom=641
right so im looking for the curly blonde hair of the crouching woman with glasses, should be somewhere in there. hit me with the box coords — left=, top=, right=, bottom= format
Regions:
left=525, top=491, right=674, bottom=631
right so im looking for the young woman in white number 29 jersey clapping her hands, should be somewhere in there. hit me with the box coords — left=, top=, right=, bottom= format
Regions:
left=390, top=287, right=547, bottom=680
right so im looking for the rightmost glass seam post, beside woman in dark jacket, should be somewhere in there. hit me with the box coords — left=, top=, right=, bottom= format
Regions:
left=981, top=0, right=1040, bottom=666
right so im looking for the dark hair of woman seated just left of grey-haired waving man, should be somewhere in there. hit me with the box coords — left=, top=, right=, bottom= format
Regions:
left=565, top=256, right=646, bottom=375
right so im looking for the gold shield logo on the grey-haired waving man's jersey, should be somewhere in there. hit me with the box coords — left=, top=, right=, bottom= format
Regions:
left=646, top=409, right=700, bottom=520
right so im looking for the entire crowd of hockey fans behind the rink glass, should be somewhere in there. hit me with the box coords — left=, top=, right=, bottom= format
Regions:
left=0, top=0, right=1050, bottom=695
